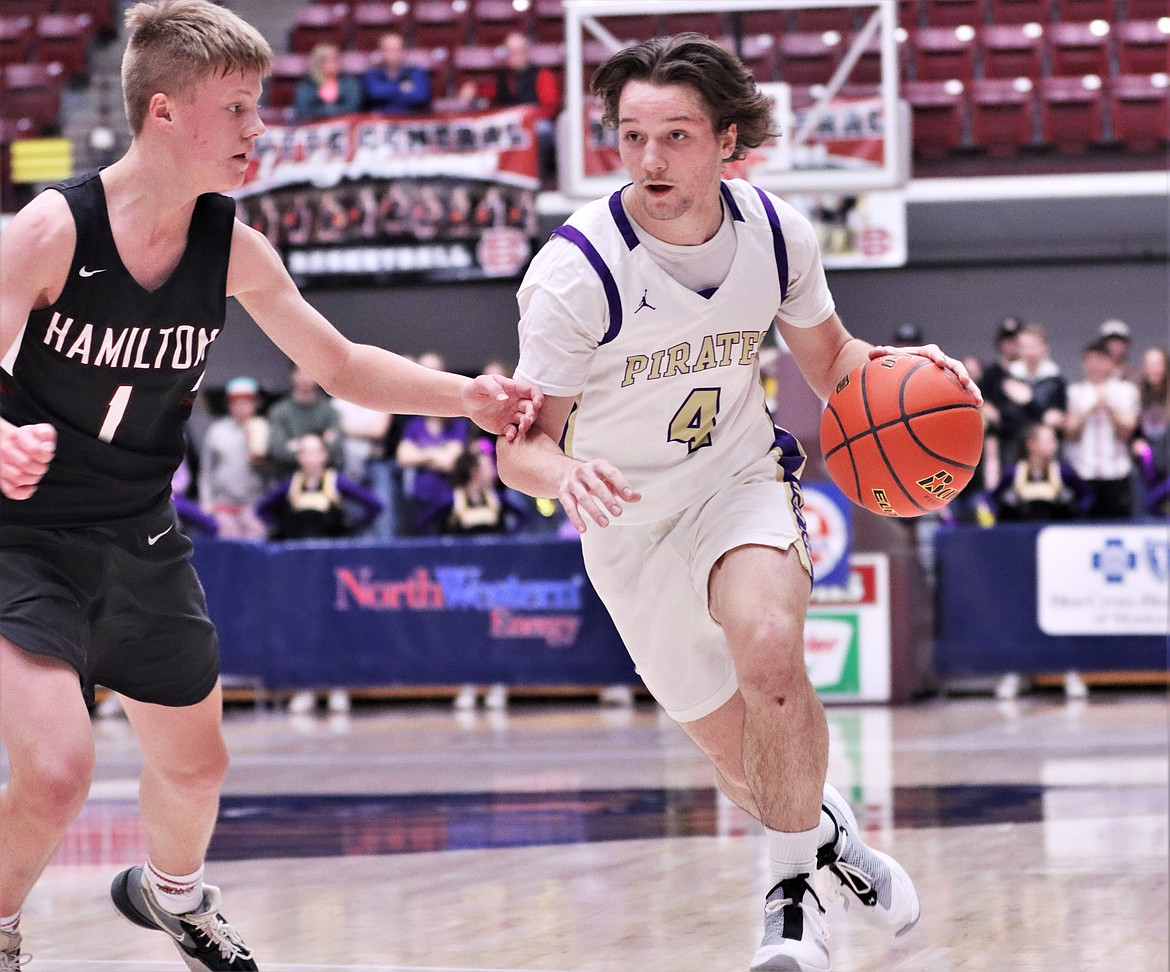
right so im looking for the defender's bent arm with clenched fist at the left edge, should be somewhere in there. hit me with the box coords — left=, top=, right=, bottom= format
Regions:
left=0, top=192, right=77, bottom=499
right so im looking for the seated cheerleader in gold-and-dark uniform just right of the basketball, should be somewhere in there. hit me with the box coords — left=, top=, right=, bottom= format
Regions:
left=991, top=423, right=1093, bottom=522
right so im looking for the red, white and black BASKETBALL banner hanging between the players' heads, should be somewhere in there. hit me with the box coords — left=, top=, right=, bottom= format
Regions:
left=234, top=108, right=539, bottom=285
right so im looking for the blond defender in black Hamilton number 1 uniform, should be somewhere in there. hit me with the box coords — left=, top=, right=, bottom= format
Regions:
left=0, top=0, right=541, bottom=970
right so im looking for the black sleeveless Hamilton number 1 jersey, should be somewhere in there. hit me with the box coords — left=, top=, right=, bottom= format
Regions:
left=0, top=172, right=235, bottom=526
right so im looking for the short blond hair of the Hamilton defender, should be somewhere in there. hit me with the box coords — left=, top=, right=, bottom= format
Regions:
left=122, top=0, right=273, bottom=135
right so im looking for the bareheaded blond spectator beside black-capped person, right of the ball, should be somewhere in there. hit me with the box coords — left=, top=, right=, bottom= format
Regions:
left=996, top=324, right=1068, bottom=468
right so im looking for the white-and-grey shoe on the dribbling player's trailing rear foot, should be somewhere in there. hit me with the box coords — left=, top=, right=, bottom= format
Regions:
left=817, top=784, right=922, bottom=936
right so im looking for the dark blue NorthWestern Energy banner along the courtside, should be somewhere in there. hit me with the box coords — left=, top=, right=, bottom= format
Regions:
left=195, top=537, right=636, bottom=689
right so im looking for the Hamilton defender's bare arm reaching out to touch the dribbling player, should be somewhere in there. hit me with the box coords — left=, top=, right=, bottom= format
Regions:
left=227, top=221, right=543, bottom=439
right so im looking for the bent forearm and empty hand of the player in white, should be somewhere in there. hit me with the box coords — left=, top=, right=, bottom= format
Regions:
left=496, top=397, right=641, bottom=533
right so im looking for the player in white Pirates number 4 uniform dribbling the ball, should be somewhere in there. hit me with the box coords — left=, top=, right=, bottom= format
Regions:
left=500, top=34, right=979, bottom=972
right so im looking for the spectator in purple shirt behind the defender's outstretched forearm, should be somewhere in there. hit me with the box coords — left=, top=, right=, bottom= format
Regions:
left=394, top=352, right=472, bottom=536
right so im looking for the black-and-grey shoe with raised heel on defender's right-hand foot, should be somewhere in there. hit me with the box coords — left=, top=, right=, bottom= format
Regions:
left=110, top=867, right=257, bottom=972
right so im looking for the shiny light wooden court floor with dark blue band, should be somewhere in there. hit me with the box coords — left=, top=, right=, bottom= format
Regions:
left=0, top=689, right=1168, bottom=972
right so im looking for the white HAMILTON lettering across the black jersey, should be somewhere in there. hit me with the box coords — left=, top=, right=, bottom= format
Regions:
left=44, top=311, right=220, bottom=371
